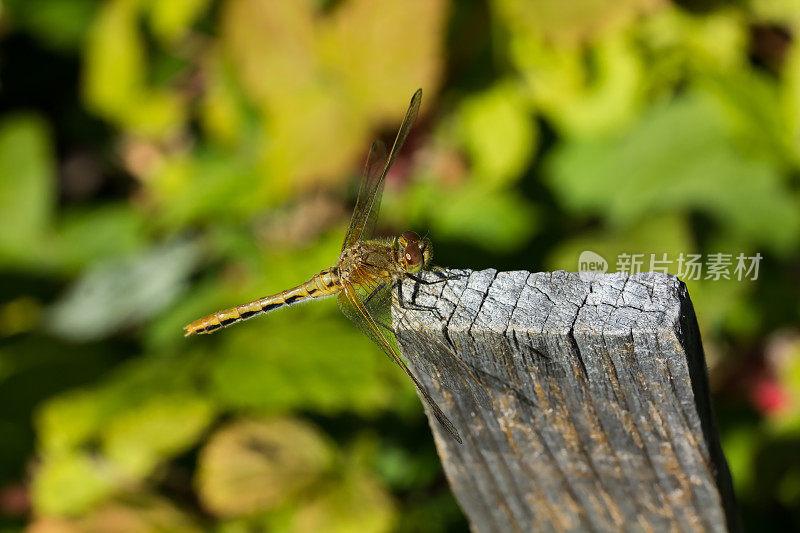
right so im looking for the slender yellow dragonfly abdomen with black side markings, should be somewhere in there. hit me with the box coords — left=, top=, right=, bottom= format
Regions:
left=183, top=267, right=341, bottom=337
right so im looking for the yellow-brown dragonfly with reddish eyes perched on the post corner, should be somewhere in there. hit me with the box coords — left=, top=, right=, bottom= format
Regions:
left=184, top=89, right=462, bottom=444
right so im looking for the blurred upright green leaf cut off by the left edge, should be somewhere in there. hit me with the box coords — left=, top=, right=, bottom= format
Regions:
left=0, top=115, right=55, bottom=264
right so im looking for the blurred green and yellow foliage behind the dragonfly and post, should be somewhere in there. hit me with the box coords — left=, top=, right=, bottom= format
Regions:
left=0, top=0, right=800, bottom=532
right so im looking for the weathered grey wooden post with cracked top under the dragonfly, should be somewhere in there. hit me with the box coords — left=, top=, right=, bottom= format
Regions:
left=393, top=270, right=741, bottom=532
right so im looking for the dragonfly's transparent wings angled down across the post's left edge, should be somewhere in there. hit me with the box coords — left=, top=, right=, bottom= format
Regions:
left=338, top=281, right=462, bottom=444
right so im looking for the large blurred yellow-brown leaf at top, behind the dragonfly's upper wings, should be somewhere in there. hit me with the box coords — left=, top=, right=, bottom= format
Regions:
left=222, top=0, right=446, bottom=191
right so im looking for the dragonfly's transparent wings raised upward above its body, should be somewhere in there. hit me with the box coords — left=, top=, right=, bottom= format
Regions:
left=342, top=89, right=422, bottom=254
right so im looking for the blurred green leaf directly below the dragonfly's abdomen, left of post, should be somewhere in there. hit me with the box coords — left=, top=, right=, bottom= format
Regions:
left=208, top=308, right=401, bottom=414
